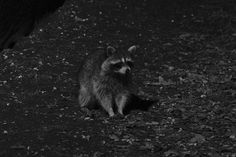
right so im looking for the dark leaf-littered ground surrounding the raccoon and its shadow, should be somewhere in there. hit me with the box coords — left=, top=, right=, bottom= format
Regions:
left=0, top=0, right=236, bottom=157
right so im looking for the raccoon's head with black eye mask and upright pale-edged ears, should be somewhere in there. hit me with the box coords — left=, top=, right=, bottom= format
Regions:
left=101, top=46, right=137, bottom=75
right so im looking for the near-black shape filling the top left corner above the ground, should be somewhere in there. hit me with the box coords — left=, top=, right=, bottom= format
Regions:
left=0, top=0, right=65, bottom=51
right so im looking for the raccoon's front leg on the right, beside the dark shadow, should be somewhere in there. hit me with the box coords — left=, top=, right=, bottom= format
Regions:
left=115, top=93, right=129, bottom=115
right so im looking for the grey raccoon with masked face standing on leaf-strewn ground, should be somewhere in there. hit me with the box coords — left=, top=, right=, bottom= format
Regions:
left=78, top=46, right=137, bottom=117
